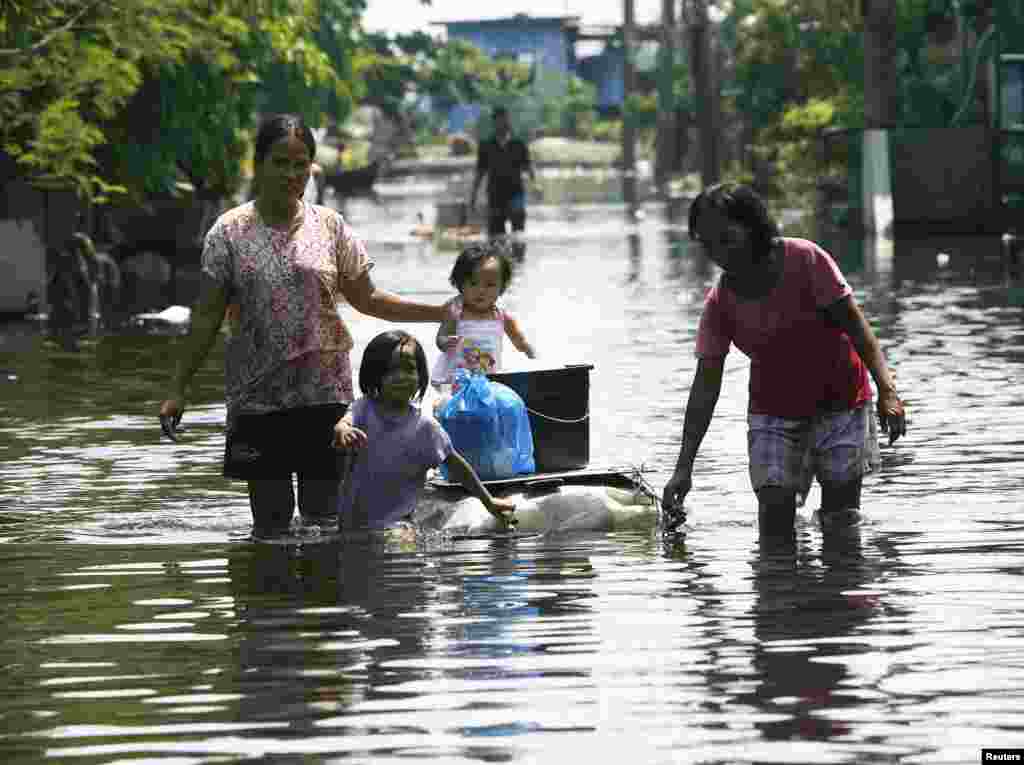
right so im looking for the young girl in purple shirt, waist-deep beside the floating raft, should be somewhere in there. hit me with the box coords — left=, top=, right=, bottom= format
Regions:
left=335, top=330, right=515, bottom=529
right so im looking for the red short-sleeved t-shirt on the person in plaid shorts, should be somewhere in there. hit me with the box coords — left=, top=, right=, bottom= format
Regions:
left=696, top=238, right=871, bottom=419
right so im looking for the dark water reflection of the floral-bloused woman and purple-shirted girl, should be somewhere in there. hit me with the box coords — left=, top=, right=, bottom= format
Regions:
left=228, top=543, right=433, bottom=738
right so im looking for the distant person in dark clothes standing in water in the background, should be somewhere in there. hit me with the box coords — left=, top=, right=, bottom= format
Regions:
left=469, top=107, right=537, bottom=237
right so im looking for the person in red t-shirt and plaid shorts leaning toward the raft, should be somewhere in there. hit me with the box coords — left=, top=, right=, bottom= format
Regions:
left=663, top=183, right=906, bottom=535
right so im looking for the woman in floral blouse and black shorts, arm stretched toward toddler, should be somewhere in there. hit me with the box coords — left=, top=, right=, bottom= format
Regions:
left=160, top=115, right=445, bottom=537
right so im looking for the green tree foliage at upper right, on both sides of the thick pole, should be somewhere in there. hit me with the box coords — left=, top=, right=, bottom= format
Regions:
left=720, top=0, right=985, bottom=191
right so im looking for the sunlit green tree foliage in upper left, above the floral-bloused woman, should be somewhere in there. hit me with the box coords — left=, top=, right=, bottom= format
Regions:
left=0, top=0, right=364, bottom=199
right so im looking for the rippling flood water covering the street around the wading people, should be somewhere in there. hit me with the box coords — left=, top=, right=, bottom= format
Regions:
left=0, top=173, right=1024, bottom=765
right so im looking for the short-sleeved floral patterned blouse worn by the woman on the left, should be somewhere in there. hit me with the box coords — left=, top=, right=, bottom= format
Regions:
left=203, top=202, right=373, bottom=427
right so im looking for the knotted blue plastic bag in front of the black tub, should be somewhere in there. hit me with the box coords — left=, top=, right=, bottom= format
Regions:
left=437, top=370, right=537, bottom=480
